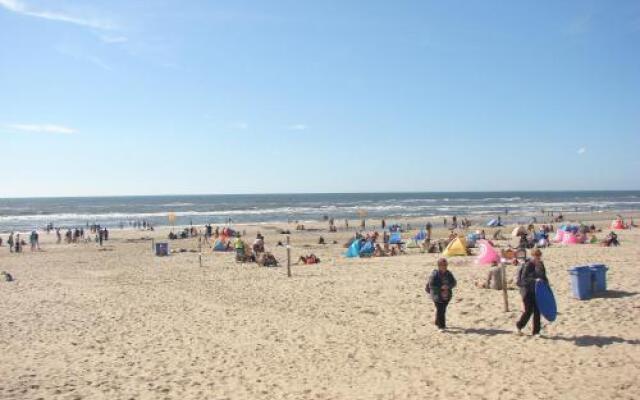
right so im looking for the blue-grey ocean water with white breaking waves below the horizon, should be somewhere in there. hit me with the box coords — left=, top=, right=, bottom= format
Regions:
left=0, top=191, right=640, bottom=232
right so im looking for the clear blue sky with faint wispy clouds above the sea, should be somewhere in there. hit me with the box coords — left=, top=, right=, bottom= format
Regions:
left=0, top=0, right=640, bottom=197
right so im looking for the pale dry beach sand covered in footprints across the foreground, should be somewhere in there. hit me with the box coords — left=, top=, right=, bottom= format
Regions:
left=0, top=216, right=640, bottom=400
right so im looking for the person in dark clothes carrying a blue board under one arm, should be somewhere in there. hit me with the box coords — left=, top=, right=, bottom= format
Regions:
left=516, top=249, right=549, bottom=335
